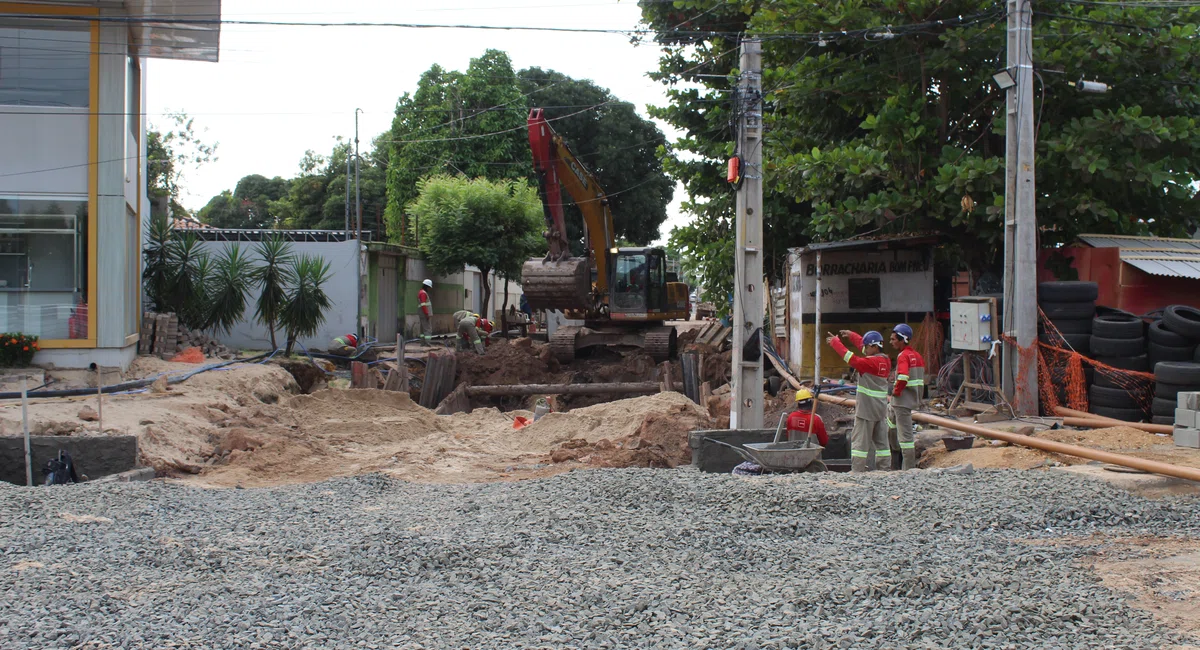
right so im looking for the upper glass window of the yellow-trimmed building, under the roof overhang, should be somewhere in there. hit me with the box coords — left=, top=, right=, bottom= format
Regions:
left=0, top=18, right=91, bottom=108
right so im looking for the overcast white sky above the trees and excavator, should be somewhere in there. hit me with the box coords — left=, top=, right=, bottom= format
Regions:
left=148, top=0, right=683, bottom=244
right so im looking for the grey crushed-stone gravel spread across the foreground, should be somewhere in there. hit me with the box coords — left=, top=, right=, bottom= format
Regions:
left=0, top=470, right=1200, bottom=650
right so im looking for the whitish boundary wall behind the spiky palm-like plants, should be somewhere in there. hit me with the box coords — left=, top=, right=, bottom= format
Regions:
left=202, top=240, right=359, bottom=350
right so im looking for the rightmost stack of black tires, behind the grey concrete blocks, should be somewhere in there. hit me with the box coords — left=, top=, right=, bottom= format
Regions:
left=1147, top=305, right=1200, bottom=425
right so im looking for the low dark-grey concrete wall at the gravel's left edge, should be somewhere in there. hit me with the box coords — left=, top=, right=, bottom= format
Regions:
left=0, top=435, right=138, bottom=486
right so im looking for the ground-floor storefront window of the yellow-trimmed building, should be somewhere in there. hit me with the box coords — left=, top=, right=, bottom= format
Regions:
left=0, top=197, right=88, bottom=339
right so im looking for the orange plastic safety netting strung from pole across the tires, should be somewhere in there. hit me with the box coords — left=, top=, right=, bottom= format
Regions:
left=1019, top=309, right=1154, bottom=415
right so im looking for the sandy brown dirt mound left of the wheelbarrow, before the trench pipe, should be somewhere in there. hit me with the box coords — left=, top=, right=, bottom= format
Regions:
left=544, top=392, right=713, bottom=468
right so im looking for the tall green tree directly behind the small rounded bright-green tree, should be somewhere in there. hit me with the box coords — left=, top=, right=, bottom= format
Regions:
left=380, top=49, right=530, bottom=242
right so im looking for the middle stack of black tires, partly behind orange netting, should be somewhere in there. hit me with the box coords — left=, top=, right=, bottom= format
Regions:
left=1087, top=308, right=1142, bottom=422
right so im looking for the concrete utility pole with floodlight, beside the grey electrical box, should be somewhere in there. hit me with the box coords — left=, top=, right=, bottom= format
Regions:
left=1002, top=0, right=1038, bottom=415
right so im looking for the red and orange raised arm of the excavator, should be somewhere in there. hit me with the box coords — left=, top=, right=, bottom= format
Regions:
left=527, top=108, right=614, bottom=294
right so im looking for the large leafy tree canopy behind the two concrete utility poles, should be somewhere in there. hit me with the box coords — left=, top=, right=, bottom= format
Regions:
left=642, top=0, right=1200, bottom=303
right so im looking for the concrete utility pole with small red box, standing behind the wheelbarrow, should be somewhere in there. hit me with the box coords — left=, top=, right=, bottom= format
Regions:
left=730, top=40, right=769, bottom=429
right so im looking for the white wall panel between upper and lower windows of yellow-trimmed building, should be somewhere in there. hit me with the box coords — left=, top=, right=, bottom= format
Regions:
left=0, top=106, right=88, bottom=197
